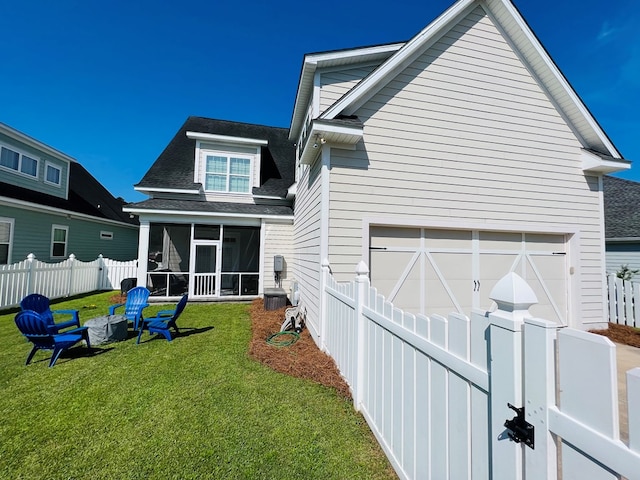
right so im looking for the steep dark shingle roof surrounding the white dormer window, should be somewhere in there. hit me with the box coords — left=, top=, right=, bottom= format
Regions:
left=135, top=117, right=295, bottom=197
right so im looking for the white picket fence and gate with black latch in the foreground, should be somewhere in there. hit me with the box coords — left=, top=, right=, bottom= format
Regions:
left=319, top=262, right=640, bottom=480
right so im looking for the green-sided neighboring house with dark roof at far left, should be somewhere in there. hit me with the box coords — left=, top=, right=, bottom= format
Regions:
left=0, top=123, right=138, bottom=265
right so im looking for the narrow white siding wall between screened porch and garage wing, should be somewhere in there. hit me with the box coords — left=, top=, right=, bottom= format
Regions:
left=264, top=222, right=294, bottom=294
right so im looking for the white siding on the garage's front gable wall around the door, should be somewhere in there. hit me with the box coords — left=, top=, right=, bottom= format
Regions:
left=329, top=8, right=604, bottom=324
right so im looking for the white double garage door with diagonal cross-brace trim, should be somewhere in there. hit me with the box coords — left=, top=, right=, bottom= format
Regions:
left=369, top=227, right=568, bottom=325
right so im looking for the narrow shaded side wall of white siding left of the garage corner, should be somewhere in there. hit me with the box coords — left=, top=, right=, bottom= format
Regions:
left=292, top=158, right=324, bottom=337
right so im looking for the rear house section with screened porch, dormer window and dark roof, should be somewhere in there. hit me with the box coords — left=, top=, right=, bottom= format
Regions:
left=125, top=117, right=295, bottom=300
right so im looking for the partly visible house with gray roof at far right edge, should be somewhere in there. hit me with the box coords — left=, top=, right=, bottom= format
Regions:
left=604, top=176, right=640, bottom=273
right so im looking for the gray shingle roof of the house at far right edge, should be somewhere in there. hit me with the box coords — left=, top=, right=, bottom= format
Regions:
left=603, top=175, right=640, bottom=239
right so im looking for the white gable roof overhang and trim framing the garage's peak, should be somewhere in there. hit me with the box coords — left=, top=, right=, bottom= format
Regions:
left=319, top=0, right=627, bottom=162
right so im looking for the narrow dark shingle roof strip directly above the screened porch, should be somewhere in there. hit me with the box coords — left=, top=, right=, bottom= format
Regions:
left=130, top=198, right=293, bottom=216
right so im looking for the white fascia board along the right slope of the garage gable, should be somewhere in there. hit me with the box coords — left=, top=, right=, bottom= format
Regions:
left=486, top=0, right=622, bottom=158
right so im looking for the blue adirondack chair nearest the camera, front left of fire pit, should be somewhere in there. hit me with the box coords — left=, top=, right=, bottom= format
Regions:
left=15, top=310, right=91, bottom=367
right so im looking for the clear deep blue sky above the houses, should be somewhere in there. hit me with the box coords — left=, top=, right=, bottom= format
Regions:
left=0, top=0, right=640, bottom=202
